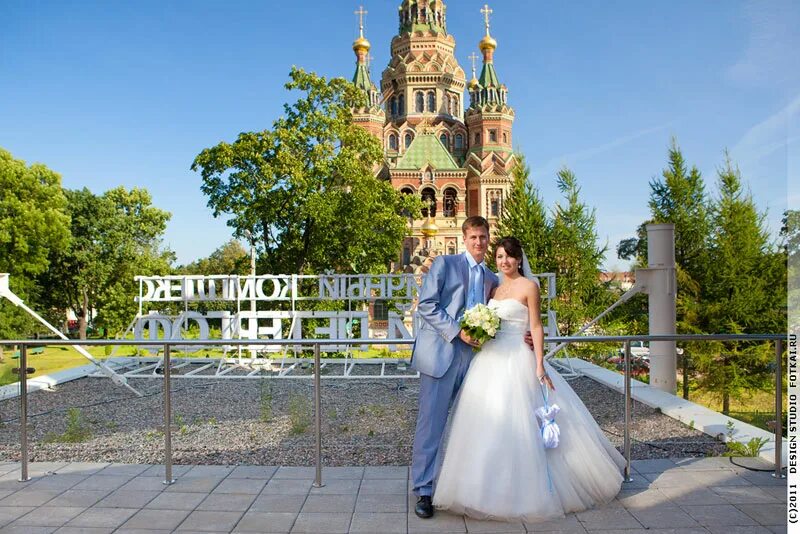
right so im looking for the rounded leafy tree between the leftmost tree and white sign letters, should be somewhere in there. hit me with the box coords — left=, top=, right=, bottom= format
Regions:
left=43, top=187, right=171, bottom=339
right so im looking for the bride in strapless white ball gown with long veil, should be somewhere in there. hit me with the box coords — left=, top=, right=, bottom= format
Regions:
left=433, top=237, right=624, bottom=522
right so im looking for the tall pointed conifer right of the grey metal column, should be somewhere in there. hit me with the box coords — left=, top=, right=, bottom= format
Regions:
left=697, top=153, right=786, bottom=414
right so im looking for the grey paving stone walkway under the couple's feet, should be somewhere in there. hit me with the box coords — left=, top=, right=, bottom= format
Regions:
left=0, top=458, right=786, bottom=534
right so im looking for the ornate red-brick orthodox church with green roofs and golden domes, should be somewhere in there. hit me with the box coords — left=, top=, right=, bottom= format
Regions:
left=353, top=0, right=515, bottom=272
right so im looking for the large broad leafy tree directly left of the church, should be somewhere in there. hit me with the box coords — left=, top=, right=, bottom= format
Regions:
left=192, top=68, right=420, bottom=274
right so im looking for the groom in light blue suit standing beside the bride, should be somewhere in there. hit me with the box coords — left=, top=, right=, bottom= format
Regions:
left=411, top=216, right=498, bottom=518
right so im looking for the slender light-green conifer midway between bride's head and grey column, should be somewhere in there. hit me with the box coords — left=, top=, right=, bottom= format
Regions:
left=552, top=167, right=610, bottom=334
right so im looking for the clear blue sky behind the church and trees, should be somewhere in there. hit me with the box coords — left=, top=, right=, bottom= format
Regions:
left=0, top=0, right=800, bottom=268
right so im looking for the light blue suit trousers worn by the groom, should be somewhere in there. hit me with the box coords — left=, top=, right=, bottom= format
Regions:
left=411, top=348, right=472, bottom=496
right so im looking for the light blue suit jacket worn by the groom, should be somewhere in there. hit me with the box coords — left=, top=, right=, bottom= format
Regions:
left=411, top=253, right=498, bottom=378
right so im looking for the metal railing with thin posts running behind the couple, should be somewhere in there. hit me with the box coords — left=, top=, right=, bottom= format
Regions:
left=0, top=334, right=786, bottom=487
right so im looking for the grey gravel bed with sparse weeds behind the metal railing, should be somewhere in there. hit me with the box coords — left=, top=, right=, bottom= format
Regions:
left=0, top=370, right=725, bottom=466
